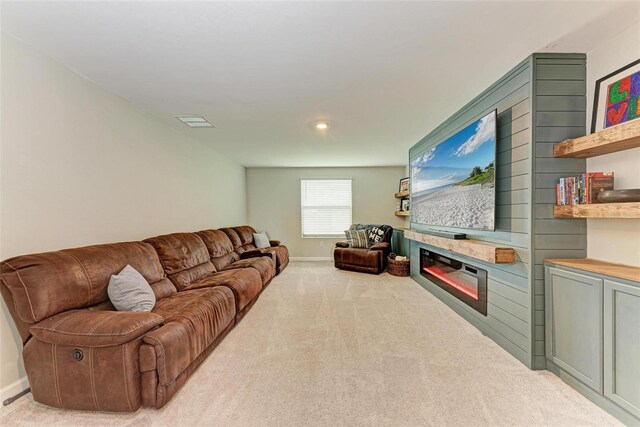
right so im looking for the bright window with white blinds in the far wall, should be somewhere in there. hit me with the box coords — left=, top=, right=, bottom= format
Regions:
left=300, top=179, right=351, bottom=237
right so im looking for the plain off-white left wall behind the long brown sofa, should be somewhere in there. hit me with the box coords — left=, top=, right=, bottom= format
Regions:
left=0, top=35, right=247, bottom=398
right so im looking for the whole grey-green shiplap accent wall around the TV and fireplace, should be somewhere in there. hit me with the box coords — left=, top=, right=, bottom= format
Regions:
left=409, top=54, right=586, bottom=369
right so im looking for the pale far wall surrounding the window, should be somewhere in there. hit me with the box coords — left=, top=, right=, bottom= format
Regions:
left=247, top=166, right=406, bottom=258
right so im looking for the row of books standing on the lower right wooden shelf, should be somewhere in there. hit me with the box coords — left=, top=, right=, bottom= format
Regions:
left=556, top=172, right=614, bottom=206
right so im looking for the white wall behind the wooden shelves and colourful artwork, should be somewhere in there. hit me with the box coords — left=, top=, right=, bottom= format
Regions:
left=587, top=21, right=640, bottom=266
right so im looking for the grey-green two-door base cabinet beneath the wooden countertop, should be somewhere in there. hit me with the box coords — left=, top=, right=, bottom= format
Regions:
left=545, top=262, right=640, bottom=425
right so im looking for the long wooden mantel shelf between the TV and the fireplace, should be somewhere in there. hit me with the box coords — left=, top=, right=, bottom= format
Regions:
left=404, top=230, right=516, bottom=264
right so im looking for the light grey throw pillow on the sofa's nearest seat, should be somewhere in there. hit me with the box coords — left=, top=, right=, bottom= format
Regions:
left=107, top=265, right=156, bottom=311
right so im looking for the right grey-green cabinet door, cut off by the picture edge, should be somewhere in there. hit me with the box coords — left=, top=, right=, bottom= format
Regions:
left=604, top=280, right=640, bottom=417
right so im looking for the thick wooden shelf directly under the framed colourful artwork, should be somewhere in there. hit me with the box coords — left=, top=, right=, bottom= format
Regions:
left=553, top=120, right=640, bottom=158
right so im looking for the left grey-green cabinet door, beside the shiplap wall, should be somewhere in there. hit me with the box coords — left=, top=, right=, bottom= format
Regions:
left=545, top=267, right=602, bottom=393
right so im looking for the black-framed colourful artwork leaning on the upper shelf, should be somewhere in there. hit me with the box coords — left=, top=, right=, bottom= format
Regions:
left=591, top=59, right=640, bottom=133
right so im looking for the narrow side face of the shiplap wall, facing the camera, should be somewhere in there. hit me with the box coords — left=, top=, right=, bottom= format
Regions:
left=532, top=55, right=584, bottom=369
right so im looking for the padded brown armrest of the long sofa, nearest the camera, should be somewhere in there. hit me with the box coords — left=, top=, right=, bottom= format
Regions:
left=29, top=310, right=164, bottom=347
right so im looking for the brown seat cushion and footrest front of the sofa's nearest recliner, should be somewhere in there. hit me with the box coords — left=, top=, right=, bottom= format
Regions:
left=144, top=286, right=236, bottom=385
